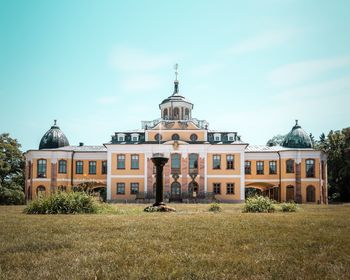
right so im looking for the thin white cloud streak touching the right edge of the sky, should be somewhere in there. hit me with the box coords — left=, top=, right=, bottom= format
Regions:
left=267, top=56, right=350, bottom=86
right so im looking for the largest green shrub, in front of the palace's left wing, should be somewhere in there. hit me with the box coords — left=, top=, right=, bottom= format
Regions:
left=24, top=192, right=99, bottom=214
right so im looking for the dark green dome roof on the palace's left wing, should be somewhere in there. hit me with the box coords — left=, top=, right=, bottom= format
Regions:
left=39, top=120, right=69, bottom=150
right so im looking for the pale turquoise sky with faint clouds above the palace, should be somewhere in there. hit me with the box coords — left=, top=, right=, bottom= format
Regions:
left=0, top=0, right=350, bottom=150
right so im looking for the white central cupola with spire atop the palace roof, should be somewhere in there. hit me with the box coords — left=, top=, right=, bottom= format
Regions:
left=159, top=64, right=193, bottom=120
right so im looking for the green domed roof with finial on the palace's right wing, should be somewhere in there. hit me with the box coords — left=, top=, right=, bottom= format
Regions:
left=282, top=120, right=312, bottom=148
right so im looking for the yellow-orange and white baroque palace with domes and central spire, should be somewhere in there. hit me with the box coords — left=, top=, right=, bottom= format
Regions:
left=25, top=73, right=327, bottom=203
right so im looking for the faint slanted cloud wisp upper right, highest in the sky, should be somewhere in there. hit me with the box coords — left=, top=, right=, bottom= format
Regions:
left=226, top=29, right=298, bottom=54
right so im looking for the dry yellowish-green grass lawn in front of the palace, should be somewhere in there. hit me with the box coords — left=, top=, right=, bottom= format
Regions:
left=0, top=204, right=350, bottom=279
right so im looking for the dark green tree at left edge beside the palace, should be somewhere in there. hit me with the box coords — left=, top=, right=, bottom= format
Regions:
left=0, top=133, right=25, bottom=204
